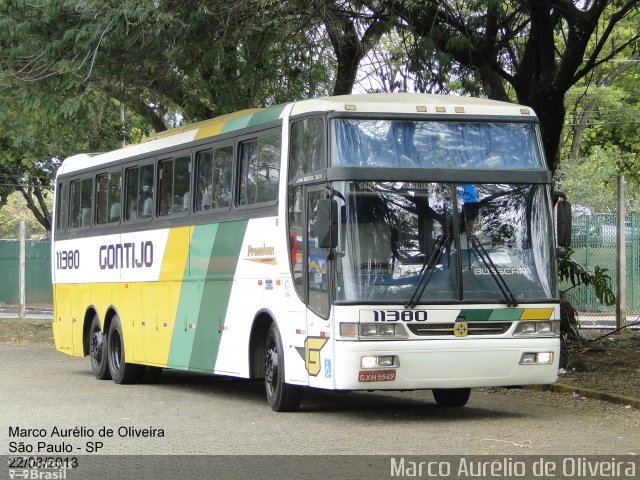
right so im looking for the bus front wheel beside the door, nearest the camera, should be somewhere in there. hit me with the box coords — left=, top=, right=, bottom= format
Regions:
left=264, top=323, right=302, bottom=412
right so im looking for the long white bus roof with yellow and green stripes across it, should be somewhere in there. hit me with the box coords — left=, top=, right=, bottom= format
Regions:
left=58, top=93, right=536, bottom=175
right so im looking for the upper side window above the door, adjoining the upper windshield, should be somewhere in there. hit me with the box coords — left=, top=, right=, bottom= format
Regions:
left=288, top=117, right=326, bottom=181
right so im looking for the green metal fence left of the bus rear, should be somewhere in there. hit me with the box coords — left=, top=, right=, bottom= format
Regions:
left=0, top=240, right=53, bottom=307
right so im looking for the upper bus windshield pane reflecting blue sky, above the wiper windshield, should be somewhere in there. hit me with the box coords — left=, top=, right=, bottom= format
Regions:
left=331, top=118, right=545, bottom=170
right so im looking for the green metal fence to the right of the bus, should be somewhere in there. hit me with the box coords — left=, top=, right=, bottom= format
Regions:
left=561, top=213, right=640, bottom=318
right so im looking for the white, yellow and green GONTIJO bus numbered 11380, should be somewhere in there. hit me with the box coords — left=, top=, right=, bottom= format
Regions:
left=52, top=94, right=560, bottom=411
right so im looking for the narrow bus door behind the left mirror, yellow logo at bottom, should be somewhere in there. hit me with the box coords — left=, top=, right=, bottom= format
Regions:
left=304, top=186, right=334, bottom=388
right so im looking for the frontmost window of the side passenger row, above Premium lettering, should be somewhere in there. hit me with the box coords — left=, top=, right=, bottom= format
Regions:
left=239, top=135, right=280, bottom=205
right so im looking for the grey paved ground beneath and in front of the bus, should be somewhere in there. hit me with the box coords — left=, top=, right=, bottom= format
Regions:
left=0, top=345, right=640, bottom=455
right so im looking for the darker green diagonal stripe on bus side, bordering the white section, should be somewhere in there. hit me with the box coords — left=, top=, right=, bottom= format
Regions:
left=189, top=220, right=248, bottom=370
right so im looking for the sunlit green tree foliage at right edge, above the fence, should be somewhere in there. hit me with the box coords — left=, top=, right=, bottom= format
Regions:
left=557, top=12, right=640, bottom=212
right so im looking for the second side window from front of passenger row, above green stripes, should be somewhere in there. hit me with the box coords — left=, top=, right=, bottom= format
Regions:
left=195, top=145, right=233, bottom=212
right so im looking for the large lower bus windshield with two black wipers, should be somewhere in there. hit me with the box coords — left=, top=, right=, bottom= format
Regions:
left=334, top=181, right=557, bottom=304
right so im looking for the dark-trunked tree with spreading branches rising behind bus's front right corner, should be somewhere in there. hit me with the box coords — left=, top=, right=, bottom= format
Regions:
left=378, top=0, right=640, bottom=171
